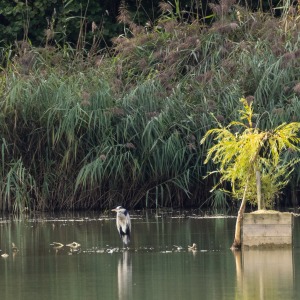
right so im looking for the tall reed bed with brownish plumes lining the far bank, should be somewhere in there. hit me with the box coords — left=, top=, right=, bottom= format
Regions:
left=0, top=0, right=300, bottom=212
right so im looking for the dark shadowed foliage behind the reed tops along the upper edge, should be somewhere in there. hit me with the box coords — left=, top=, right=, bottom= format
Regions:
left=0, top=0, right=281, bottom=48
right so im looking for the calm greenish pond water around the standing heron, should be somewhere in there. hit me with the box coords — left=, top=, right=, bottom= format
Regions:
left=0, top=212, right=300, bottom=300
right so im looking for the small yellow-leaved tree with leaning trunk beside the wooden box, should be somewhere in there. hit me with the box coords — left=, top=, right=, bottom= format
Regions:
left=201, top=98, right=300, bottom=248
